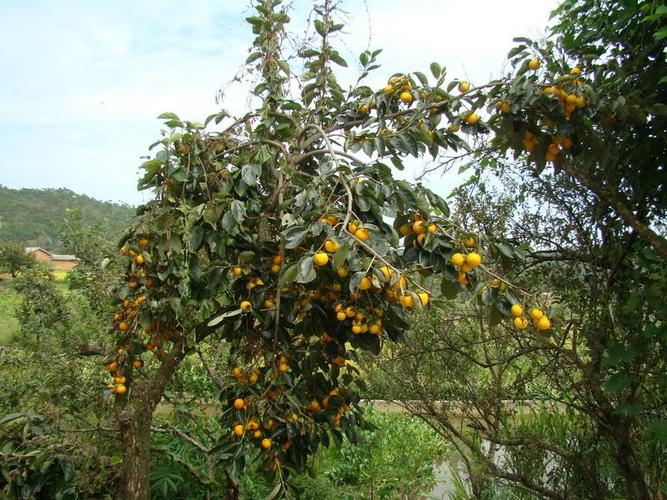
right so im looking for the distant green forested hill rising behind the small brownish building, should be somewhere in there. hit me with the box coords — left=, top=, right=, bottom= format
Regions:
left=0, top=185, right=135, bottom=251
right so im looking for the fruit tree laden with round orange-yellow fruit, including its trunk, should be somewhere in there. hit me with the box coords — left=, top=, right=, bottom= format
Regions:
left=105, top=0, right=664, bottom=498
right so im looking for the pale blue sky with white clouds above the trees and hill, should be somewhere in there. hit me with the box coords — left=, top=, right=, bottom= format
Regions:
left=0, top=0, right=558, bottom=205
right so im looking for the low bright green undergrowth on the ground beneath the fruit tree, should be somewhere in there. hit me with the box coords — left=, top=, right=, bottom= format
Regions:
left=151, top=409, right=444, bottom=500
